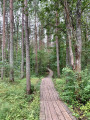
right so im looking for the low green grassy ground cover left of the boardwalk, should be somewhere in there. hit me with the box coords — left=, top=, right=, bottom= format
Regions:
left=0, top=77, right=40, bottom=120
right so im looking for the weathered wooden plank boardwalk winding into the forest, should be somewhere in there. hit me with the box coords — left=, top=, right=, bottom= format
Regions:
left=40, top=70, right=76, bottom=120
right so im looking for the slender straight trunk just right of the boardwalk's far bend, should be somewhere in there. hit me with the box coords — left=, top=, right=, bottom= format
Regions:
left=56, top=12, right=60, bottom=77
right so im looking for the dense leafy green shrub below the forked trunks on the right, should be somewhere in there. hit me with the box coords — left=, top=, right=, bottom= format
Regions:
left=63, top=68, right=90, bottom=103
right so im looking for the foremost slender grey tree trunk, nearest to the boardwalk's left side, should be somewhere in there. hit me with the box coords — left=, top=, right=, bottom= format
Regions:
left=25, top=0, right=31, bottom=94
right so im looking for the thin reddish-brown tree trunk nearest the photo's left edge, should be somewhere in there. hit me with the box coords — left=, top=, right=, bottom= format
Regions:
left=1, top=0, right=5, bottom=79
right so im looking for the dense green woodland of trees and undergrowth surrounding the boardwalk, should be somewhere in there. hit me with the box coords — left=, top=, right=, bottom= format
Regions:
left=0, top=0, right=90, bottom=120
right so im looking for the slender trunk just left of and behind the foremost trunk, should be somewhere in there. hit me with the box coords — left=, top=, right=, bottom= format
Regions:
left=21, top=2, right=24, bottom=79
